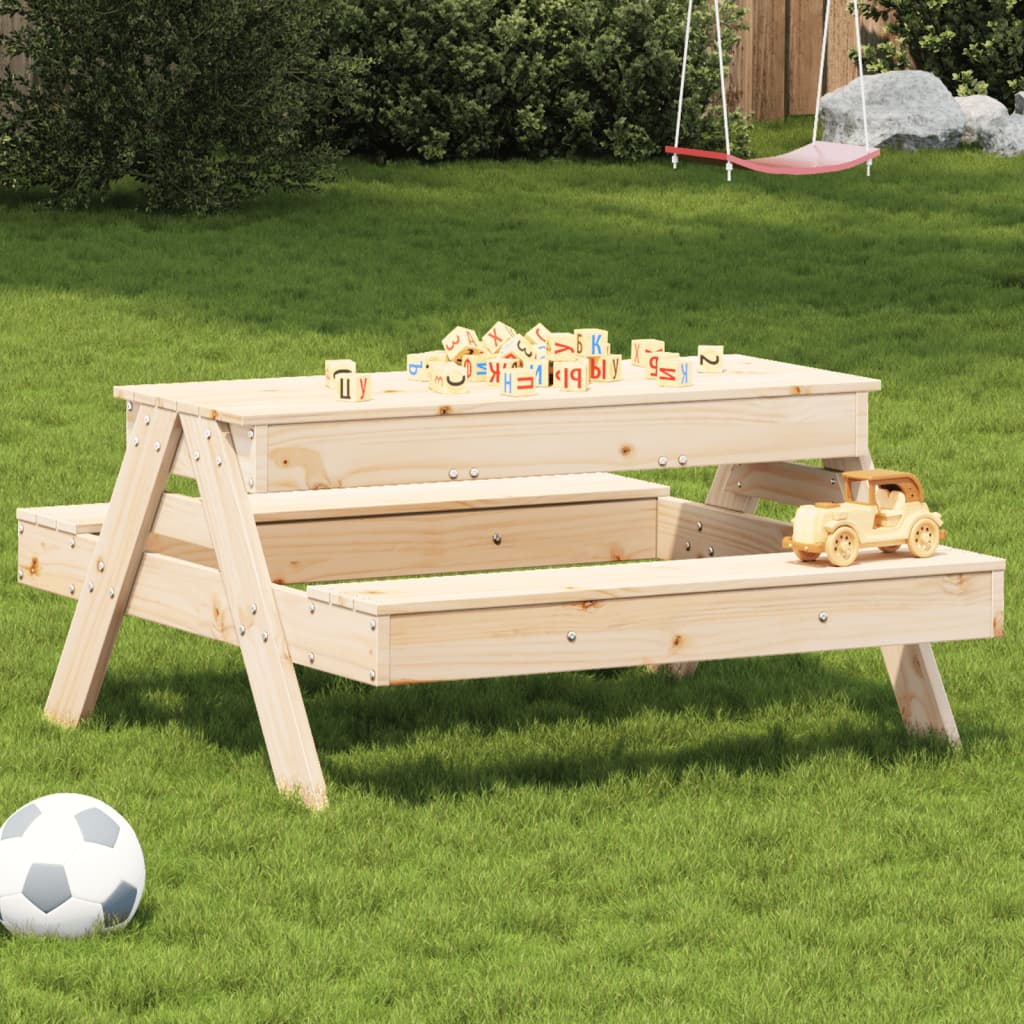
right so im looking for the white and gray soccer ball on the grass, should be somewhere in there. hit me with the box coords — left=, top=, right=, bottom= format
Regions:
left=0, top=793, right=145, bottom=938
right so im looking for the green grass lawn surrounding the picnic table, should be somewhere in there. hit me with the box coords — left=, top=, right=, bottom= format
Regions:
left=0, top=119, right=1024, bottom=1024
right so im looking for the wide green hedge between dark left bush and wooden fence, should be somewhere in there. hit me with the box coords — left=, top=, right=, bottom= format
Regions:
left=330, top=0, right=750, bottom=160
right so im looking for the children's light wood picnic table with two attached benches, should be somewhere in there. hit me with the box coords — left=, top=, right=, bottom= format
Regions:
left=17, top=354, right=1005, bottom=807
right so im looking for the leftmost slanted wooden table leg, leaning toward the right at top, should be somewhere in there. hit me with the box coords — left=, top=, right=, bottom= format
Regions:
left=46, top=409, right=181, bottom=725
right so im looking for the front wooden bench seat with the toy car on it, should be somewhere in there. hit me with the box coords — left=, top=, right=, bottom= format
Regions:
left=307, top=547, right=1005, bottom=684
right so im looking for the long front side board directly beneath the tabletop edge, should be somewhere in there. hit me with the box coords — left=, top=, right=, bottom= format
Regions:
left=268, top=391, right=858, bottom=490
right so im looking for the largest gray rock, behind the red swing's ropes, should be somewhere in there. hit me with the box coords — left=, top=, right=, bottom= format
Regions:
left=821, top=71, right=966, bottom=150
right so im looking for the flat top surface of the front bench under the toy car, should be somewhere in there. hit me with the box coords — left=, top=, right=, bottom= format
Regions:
left=306, top=546, right=1006, bottom=610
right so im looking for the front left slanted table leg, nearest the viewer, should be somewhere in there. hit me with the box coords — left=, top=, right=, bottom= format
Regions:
left=181, top=414, right=327, bottom=808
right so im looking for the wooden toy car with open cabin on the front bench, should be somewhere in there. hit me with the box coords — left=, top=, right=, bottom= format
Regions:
left=782, top=469, right=946, bottom=565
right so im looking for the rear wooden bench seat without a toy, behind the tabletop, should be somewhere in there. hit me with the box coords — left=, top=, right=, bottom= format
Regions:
left=17, top=473, right=669, bottom=584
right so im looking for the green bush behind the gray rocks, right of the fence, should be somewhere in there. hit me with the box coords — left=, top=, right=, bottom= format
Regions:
left=865, top=0, right=1024, bottom=105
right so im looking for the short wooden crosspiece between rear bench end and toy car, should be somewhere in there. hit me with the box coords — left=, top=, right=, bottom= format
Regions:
left=657, top=498, right=793, bottom=559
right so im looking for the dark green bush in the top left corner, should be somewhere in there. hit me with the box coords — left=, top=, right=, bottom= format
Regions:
left=0, top=0, right=349, bottom=213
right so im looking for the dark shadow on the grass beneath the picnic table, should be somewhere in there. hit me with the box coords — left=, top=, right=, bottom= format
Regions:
left=88, top=652, right=991, bottom=803
